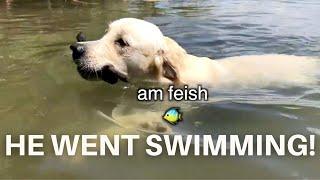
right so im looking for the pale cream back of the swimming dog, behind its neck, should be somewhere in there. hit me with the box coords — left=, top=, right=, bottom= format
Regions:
left=212, top=54, right=320, bottom=88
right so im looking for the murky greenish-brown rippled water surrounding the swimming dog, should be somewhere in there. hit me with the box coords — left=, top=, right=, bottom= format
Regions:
left=0, top=0, right=320, bottom=178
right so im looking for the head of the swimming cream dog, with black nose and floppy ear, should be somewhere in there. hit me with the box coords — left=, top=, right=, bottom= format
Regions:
left=70, top=18, right=185, bottom=84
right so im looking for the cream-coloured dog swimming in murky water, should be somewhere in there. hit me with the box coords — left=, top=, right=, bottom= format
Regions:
left=70, top=18, right=319, bottom=88
